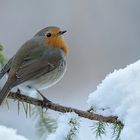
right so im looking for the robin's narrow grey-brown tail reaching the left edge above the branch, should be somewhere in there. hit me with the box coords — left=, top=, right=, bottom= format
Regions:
left=0, top=82, right=11, bottom=105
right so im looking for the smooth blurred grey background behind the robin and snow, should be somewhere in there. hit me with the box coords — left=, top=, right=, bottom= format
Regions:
left=0, top=0, right=140, bottom=140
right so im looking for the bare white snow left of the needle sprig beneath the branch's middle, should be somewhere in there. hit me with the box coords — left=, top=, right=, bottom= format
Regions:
left=47, top=112, right=79, bottom=140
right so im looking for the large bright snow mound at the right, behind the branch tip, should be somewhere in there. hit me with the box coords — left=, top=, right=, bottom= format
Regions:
left=88, top=60, right=140, bottom=140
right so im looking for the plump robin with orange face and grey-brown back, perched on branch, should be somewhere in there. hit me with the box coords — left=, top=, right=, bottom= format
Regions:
left=0, top=26, right=69, bottom=105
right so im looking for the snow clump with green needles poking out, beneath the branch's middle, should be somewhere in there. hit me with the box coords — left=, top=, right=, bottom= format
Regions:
left=47, top=113, right=80, bottom=140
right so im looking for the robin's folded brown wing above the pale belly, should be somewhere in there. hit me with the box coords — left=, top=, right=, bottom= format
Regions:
left=16, top=57, right=63, bottom=85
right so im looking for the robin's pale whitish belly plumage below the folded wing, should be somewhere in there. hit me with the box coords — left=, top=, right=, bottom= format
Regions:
left=21, top=60, right=66, bottom=90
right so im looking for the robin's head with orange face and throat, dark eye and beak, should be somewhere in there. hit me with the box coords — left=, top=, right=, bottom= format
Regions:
left=35, top=26, right=69, bottom=54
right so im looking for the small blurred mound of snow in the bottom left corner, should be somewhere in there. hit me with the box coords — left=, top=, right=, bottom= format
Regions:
left=0, top=125, right=28, bottom=140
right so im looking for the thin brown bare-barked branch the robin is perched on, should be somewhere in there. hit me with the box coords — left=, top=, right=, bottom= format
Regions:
left=8, top=92, right=124, bottom=128
